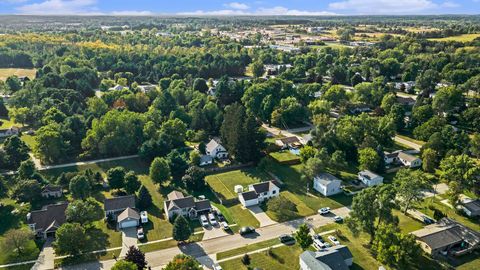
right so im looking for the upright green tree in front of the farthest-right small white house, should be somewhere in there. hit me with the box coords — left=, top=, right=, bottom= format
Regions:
left=393, top=168, right=428, bottom=214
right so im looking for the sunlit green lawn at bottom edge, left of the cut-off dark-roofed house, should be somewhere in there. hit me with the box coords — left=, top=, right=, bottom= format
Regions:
left=220, top=245, right=303, bottom=270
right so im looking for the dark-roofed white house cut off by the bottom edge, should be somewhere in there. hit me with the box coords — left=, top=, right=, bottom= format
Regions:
left=299, top=245, right=353, bottom=270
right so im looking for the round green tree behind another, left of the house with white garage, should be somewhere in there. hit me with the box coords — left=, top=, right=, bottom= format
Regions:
left=65, top=198, right=103, bottom=225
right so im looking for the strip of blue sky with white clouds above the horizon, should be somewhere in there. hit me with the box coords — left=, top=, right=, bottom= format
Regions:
left=0, top=0, right=480, bottom=16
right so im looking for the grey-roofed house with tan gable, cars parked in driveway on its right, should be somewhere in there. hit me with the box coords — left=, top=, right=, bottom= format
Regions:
left=163, top=191, right=212, bottom=219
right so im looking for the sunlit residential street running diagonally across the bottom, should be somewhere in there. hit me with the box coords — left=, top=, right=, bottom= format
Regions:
left=62, top=207, right=350, bottom=270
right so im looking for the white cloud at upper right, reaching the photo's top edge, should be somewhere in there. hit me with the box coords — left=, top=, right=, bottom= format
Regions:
left=329, top=0, right=439, bottom=14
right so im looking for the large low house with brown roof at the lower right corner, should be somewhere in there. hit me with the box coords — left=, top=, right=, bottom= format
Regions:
left=412, top=218, right=480, bottom=257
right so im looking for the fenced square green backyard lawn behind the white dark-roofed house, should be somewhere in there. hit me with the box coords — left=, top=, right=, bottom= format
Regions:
left=205, top=168, right=270, bottom=200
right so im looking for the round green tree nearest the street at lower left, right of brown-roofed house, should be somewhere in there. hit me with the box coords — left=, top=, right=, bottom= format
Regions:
left=53, top=223, right=88, bottom=256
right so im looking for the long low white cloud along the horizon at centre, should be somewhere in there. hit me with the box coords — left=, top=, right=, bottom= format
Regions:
left=177, top=6, right=337, bottom=16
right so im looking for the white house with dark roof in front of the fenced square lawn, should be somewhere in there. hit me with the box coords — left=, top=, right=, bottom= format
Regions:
left=238, top=181, right=280, bottom=207
